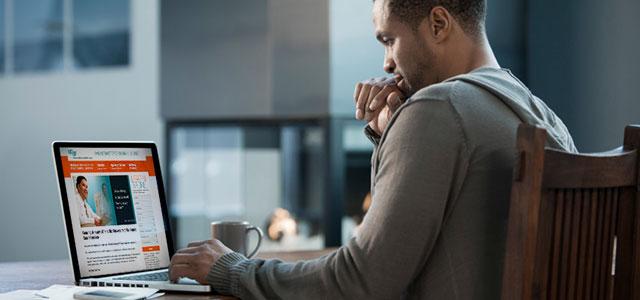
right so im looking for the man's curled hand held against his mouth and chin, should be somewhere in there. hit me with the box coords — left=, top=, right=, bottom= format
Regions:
left=353, top=77, right=405, bottom=135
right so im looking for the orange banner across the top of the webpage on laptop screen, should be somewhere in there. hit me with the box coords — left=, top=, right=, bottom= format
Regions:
left=60, top=156, right=156, bottom=177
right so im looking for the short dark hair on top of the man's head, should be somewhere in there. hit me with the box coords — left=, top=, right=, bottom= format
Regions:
left=374, top=0, right=487, bottom=36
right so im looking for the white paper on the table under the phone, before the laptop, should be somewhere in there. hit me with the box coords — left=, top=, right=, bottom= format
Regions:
left=36, top=284, right=158, bottom=300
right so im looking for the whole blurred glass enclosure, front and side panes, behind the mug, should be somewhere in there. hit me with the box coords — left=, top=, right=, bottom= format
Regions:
left=168, top=119, right=380, bottom=251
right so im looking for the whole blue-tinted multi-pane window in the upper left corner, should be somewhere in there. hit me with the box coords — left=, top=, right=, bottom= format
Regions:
left=0, top=0, right=131, bottom=74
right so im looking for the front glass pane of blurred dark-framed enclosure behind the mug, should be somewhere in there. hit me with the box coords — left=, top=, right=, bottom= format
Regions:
left=168, top=125, right=324, bottom=251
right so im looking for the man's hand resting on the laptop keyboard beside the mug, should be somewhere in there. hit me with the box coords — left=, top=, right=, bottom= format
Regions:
left=169, top=240, right=233, bottom=284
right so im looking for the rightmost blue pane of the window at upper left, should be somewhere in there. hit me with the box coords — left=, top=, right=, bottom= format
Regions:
left=73, top=0, right=130, bottom=68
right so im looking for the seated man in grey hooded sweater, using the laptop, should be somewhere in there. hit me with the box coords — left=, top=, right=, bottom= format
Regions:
left=171, top=0, right=575, bottom=299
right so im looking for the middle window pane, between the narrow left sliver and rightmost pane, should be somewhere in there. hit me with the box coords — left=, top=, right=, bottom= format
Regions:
left=13, top=0, right=63, bottom=73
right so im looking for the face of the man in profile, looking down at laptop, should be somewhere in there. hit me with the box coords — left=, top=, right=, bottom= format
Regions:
left=373, top=0, right=437, bottom=97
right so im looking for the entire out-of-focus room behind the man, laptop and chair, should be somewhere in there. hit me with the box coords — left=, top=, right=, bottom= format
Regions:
left=0, top=0, right=640, bottom=261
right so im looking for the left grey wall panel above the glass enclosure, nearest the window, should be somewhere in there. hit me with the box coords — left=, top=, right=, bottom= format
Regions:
left=160, top=0, right=270, bottom=119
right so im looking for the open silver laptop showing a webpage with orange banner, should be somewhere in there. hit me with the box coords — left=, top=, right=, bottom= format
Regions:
left=52, top=142, right=211, bottom=292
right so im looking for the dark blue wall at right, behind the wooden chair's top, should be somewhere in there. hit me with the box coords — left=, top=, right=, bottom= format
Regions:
left=527, top=0, right=640, bottom=152
